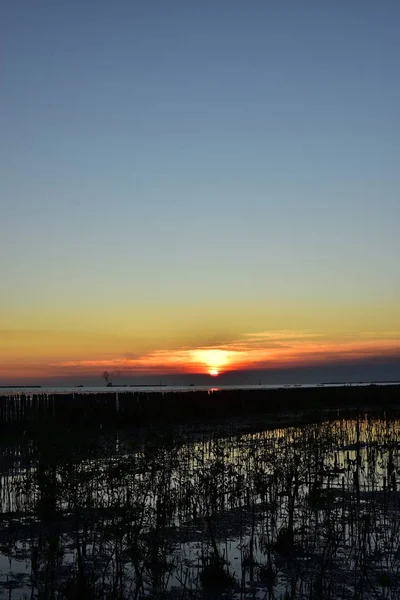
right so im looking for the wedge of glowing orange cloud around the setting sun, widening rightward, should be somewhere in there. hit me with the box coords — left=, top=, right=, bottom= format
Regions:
left=52, top=330, right=400, bottom=375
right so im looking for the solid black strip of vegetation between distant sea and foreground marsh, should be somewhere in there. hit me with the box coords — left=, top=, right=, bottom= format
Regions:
left=0, top=385, right=400, bottom=435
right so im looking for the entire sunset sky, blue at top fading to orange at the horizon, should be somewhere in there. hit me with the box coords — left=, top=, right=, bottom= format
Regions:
left=0, top=0, right=400, bottom=384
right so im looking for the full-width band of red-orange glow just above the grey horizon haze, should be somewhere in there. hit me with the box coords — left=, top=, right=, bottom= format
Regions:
left=0, top=330, right=400, bottom=382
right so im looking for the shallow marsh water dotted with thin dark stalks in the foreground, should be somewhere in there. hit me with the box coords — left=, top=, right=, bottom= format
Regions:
left=0, top=415, right=400, bottom=600
